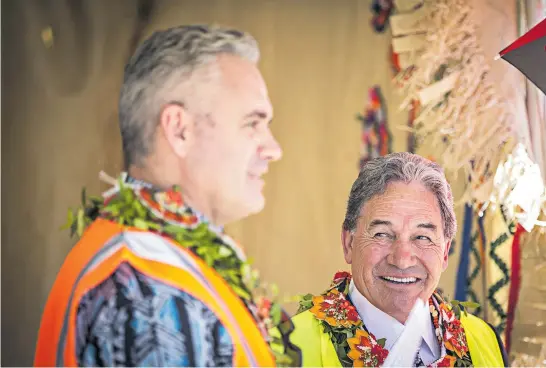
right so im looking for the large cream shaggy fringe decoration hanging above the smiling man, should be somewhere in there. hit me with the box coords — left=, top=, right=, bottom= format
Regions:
left=391, top=0, right=514, bottom=203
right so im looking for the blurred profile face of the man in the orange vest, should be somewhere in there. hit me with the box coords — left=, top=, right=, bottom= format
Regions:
left=187, top=54, right=282, bottom=223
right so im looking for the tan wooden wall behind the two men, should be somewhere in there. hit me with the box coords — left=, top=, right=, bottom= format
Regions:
left=2, top=0, right=472, bottom=366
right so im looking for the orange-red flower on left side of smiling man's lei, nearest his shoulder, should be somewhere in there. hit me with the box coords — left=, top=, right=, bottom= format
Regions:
left=310, top=289, right=362, bottom=327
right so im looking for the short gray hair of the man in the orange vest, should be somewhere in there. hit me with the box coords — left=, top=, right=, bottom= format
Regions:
left=119, top=25, right=260, bottom=168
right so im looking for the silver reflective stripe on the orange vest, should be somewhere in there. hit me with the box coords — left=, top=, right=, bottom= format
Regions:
left=56, top=231, right=258, bottom=366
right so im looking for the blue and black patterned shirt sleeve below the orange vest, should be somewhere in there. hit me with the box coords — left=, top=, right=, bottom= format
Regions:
left=76, top=263, right=233, bottom=367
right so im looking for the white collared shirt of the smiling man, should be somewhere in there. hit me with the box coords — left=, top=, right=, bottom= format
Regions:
left=349, top=280, right=440, bottom=365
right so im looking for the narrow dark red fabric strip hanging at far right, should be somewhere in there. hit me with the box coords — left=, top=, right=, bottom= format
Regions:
left=504, top=224, right=525, bottom=354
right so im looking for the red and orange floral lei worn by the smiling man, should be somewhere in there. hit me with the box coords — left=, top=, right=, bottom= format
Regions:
left=298, top=272, right=472, bottom=367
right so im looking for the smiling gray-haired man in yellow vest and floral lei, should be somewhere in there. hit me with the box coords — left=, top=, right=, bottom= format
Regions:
left=286, top=152, right=507, bottom=367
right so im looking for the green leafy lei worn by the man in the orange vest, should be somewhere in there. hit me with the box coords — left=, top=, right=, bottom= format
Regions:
left=63, top=173, right=301, bottom=366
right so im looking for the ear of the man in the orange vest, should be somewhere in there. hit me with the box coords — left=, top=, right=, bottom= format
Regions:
left=159, top=104, right=193, bottom=157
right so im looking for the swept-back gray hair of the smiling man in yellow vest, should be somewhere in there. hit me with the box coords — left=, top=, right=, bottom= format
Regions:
left=343, top=152, right=457, bottom=240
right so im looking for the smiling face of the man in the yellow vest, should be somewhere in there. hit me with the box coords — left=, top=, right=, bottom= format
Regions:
left=343, top=182, right=451, bottom=323
